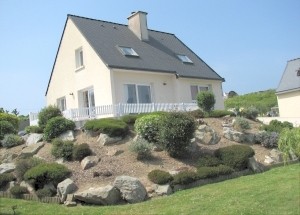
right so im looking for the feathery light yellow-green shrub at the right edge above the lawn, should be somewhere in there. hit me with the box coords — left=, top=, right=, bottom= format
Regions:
left=278, top=128, right=300, bottom=162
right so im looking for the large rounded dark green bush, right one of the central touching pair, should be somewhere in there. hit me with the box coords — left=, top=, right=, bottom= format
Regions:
left=159, top=112, right=196, bottom=157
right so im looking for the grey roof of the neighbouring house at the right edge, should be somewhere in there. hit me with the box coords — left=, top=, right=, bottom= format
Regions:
left=276, top=58, right=300, bottom=93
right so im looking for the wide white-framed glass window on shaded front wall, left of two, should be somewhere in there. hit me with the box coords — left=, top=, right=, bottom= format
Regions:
left=125, top=84, right=152, bottom=104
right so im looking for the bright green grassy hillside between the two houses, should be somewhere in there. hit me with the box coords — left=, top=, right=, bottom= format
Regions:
left=225, top=89, right=278, bottom=114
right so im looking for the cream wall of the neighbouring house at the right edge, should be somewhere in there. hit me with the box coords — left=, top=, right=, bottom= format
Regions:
left=277, top=90, right=300, bottom=117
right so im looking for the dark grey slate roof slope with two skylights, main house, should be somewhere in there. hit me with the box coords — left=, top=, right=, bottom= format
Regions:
left=68, top=15, right=224, bottom=81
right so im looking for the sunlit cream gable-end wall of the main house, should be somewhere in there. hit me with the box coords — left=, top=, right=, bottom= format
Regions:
left=46, top=19, right=112, bottom=109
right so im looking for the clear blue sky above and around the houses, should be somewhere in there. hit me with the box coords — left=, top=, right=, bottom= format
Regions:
left=0, top=0, right=300, bottom=114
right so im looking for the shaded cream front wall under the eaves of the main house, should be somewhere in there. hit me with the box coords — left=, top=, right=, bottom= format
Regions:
left=112, top=69, right=224, bottom=109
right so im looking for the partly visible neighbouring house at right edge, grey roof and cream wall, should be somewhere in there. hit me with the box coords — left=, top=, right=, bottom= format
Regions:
left=276, top=58, right=300, bottom=117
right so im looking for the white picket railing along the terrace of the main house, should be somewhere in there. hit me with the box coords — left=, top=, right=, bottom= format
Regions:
left=29, top=103, right=198, bottom=125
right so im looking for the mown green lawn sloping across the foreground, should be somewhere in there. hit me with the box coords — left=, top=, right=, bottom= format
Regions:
left=0, top=163, right=300, bottom=215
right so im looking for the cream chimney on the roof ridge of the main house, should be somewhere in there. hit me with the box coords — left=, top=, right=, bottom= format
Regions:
left=127, top=11, right=149, bottom=41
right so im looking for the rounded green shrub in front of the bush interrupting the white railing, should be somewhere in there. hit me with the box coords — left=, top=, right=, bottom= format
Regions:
left=44, top=116, right=75, bottom=141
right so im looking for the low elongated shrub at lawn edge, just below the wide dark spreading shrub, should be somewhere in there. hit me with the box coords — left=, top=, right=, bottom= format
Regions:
left=197, top=165, right=234, bottom=179
